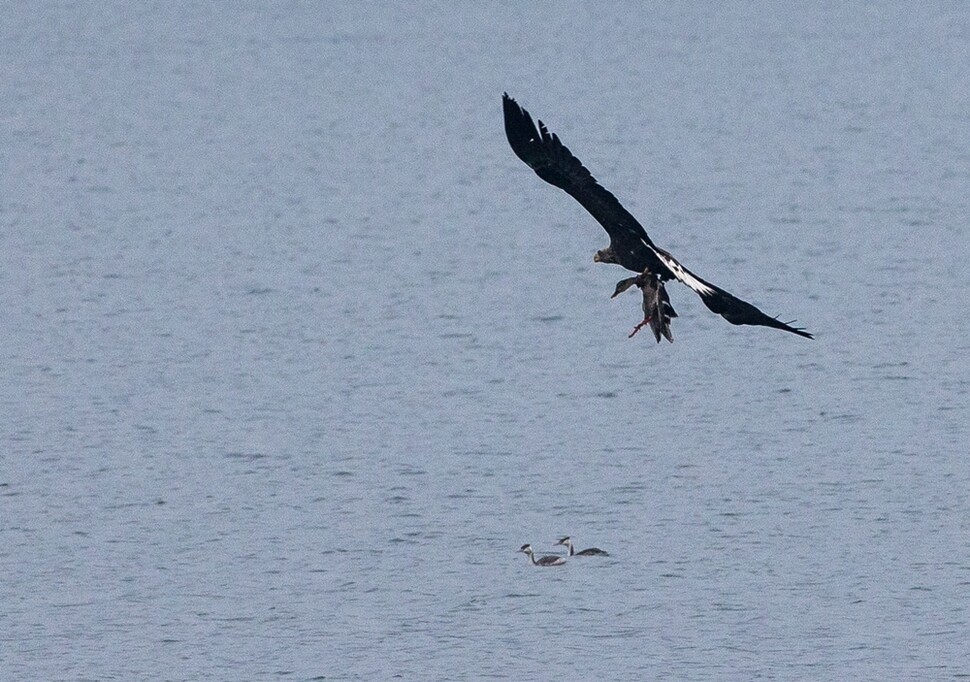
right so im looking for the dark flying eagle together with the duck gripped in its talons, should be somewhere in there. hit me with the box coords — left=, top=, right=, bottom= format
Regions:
left=502, top=93, right=813, bottom=343
